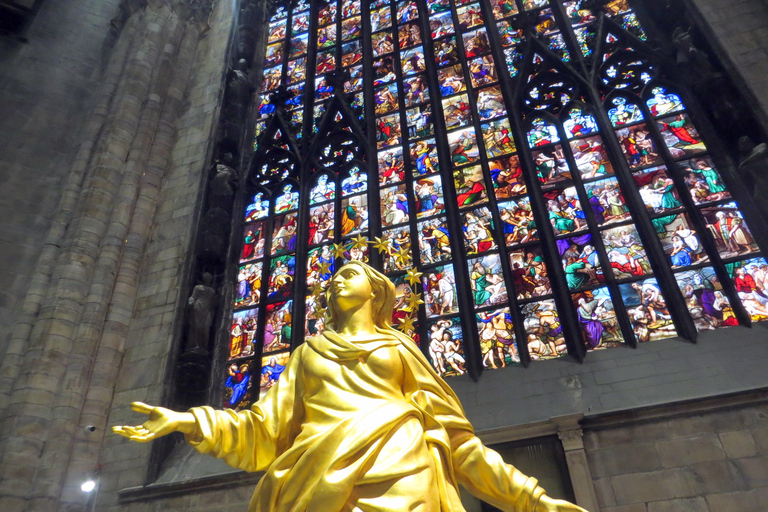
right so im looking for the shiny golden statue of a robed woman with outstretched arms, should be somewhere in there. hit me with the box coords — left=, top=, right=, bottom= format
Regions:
left=113, top=261, right=586, bottom=512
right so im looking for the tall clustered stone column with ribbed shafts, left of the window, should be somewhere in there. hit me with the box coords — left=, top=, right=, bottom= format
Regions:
left=0, top=0, right=216, bottom=511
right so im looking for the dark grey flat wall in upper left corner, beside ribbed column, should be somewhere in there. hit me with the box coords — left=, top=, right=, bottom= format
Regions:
left=0, top=0, right=119, bottom=368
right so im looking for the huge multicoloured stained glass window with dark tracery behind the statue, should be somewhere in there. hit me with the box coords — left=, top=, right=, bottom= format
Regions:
left=224, top=0, right=768, bottom=408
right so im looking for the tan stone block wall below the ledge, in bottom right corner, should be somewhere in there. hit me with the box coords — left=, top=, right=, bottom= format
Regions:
left=584, top=405, right=768, bottom=512
